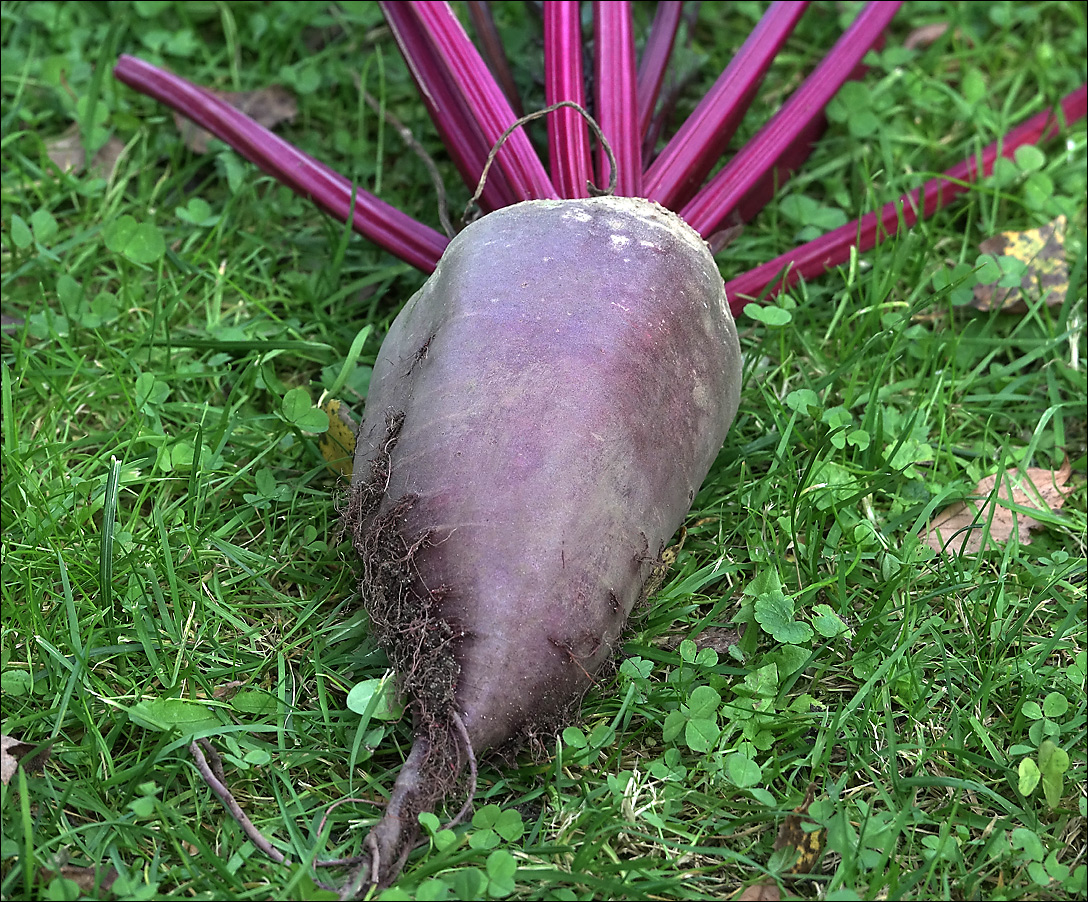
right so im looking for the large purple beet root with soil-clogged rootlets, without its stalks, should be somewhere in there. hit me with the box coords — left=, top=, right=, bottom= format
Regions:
left=345, top=197, right=741, bottom=891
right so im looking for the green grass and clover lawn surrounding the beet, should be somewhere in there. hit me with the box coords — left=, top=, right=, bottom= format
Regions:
left=0, top=2, right=1088, bottom=900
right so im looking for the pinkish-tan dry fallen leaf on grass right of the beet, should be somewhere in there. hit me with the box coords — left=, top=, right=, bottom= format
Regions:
left=922, top=460, right=1073, bottom=554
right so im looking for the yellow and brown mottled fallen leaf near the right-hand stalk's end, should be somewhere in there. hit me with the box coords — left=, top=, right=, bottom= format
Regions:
left=972, top=217, right=1070, bottom=313
